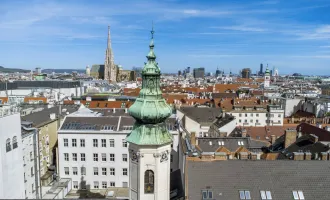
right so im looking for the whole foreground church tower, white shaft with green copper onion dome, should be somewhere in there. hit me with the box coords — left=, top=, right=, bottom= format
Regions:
left=126, top=26, right=172, bottom=200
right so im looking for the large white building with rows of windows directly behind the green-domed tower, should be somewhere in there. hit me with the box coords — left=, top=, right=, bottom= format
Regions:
left=58, top=105, right=178, bottom=190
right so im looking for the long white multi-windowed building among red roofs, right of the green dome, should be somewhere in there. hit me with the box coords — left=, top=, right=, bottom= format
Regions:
left=228, top=105, right=284, bottom=126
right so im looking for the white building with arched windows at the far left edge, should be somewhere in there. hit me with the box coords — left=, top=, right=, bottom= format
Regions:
left=0, top=108, right=25, bottom=199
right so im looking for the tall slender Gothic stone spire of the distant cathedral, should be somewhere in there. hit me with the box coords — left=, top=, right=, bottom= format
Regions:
left=104, top=26, right=117, bottom=82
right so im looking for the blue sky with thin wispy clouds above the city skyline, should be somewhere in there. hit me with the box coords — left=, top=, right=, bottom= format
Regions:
left=0, top=0, right=330, bottom=75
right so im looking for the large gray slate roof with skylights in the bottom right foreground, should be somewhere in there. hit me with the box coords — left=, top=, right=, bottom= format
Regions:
left=186, top=160, right=330, bottom=200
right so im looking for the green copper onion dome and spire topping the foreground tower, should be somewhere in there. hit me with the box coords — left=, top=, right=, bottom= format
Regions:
left=126, top=28, right=172, bottom=145
